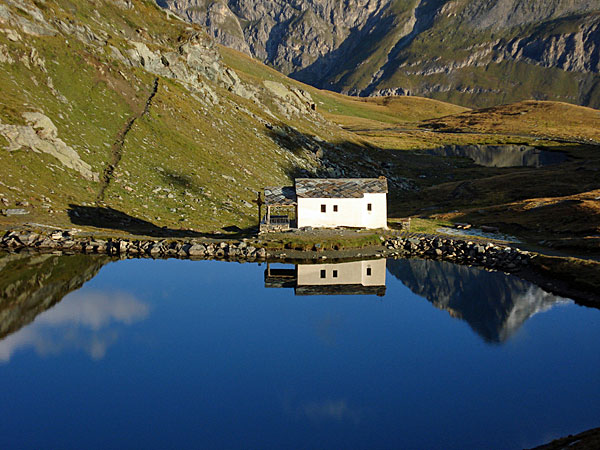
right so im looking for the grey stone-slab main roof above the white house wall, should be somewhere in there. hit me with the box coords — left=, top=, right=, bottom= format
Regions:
left=296, top=177, right=388, bottom=198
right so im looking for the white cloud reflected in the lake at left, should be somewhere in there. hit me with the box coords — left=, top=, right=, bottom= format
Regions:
left=0, top=291, right=149, bottom=363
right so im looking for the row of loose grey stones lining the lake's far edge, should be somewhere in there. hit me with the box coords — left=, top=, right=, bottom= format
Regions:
left=0, top=230, right=535, bottom=272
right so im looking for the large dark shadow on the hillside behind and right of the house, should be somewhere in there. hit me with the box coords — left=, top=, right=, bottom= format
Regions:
left=279, top=125, right=600, bottom=221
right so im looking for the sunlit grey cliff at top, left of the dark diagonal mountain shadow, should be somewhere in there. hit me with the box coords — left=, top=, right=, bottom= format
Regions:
left=159, top=0, right=393, bottom=82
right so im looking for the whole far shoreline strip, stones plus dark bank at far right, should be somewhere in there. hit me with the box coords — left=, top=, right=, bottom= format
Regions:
left=0, top=230, right=600, bottom=308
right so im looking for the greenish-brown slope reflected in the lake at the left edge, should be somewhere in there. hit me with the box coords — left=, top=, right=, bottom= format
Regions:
left=0, top=254, right=109, bottom=339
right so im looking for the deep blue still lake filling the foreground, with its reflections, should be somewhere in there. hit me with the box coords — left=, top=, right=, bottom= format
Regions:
left=0, top=255, right=600, bottom=449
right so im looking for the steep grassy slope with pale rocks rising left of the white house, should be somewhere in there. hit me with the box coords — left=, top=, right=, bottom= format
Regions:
left=0, top=0, right=408, bottom=232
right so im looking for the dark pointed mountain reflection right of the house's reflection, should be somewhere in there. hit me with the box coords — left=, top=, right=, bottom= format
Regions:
left=387, top=259, right=565, bottom=342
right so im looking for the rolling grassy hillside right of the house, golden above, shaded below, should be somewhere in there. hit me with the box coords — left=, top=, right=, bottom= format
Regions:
left=357, top=101, right=600, bottom=252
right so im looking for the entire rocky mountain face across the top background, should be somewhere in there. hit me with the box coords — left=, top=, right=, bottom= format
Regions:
left=159, top=0, right=600, bottom=107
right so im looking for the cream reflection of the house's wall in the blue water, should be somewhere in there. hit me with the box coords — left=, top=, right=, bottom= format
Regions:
left=298, top=259, right=386, bottom=286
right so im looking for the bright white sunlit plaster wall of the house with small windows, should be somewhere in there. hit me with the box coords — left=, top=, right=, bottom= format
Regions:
left=298, top=194, right=387, bottom=228
